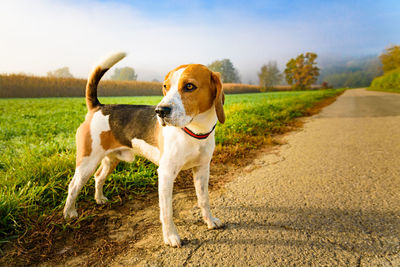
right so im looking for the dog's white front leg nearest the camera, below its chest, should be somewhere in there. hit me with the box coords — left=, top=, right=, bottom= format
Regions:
left=158, top=162, right=181, bottom=247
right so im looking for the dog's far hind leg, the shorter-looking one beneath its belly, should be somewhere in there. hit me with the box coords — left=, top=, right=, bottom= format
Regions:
left=94, top=155, right=119, bottom=204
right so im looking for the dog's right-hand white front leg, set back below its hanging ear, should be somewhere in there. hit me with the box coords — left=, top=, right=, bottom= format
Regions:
left=193, top=164, right=222, bottom=229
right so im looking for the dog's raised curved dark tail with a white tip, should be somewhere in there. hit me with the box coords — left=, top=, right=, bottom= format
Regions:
left=86, top=52, right=126, bottom=110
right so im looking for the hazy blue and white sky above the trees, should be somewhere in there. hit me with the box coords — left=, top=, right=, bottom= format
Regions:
left=0, top=0, right=400, bottom=83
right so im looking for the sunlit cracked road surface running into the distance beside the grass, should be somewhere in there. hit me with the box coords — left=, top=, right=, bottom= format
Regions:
left=47, top=89, right=400, bottom=266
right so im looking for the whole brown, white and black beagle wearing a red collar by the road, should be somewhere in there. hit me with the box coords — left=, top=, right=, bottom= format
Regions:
left=64, top=53, right=225, bottom=247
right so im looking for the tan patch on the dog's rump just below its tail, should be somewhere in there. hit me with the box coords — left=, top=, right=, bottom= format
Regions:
left=76, top=109, right=98, bottom=167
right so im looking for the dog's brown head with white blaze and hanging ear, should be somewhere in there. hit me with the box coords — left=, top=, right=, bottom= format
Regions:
left=156, top=64, right=225, bottom=127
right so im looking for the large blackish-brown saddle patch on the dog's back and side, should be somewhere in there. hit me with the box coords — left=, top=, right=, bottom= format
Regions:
left=101, top=105, right=157, bottom=147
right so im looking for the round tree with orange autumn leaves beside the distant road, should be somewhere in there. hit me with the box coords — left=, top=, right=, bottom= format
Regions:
left=285, top=53, right=319, bottom=90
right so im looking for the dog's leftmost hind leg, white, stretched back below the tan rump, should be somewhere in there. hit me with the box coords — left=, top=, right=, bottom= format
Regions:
left=64, top=155, right=103, bottom=219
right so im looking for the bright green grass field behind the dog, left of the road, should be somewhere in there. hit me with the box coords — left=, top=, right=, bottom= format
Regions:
left=0, top=90, right=341, bottom=244
